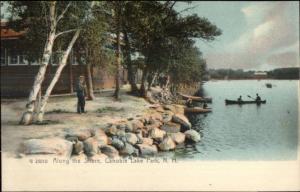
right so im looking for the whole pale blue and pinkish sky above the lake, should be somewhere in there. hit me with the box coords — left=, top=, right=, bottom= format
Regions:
left=175, top=1, right=299, bottom=70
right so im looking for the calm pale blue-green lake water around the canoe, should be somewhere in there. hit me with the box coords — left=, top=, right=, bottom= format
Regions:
left=161, top=80, right=299, bottom=160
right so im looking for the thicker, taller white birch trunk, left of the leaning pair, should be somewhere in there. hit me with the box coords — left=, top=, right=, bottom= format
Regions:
left=20, top=2, right=56, bottom=125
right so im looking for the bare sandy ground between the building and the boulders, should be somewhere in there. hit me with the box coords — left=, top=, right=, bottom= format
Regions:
left=1, top=88, right=149, bottom=157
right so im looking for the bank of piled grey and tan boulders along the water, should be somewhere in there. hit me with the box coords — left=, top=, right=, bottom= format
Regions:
left=18, top=104, right=201, bottom=160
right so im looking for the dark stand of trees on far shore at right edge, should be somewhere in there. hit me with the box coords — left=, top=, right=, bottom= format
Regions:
left=268, top=67, right=300, bottom=79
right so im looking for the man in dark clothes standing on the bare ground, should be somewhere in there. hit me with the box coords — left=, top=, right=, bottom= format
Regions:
left=76, top=76, right=86, bottom=114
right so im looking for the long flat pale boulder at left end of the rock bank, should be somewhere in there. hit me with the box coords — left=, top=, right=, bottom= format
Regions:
left=20, top=137, right=73, bottom=158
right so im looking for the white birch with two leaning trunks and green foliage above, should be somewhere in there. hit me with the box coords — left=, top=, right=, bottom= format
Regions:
left=11, top=1, right=98, bottom=125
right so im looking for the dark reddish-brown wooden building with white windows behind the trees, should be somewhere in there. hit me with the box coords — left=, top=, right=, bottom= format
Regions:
left=1, top=22, right=127, bottom=97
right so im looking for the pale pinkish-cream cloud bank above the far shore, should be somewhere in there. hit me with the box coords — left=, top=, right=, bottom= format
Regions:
left=206, top=2, right=299, bottom=69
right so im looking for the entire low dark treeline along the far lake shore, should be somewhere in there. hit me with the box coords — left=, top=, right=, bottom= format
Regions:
left=208, top=67, right=300, bottom=79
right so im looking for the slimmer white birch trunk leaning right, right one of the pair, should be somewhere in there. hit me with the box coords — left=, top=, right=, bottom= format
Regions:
left=37, top=29, right=80, bottom=122
